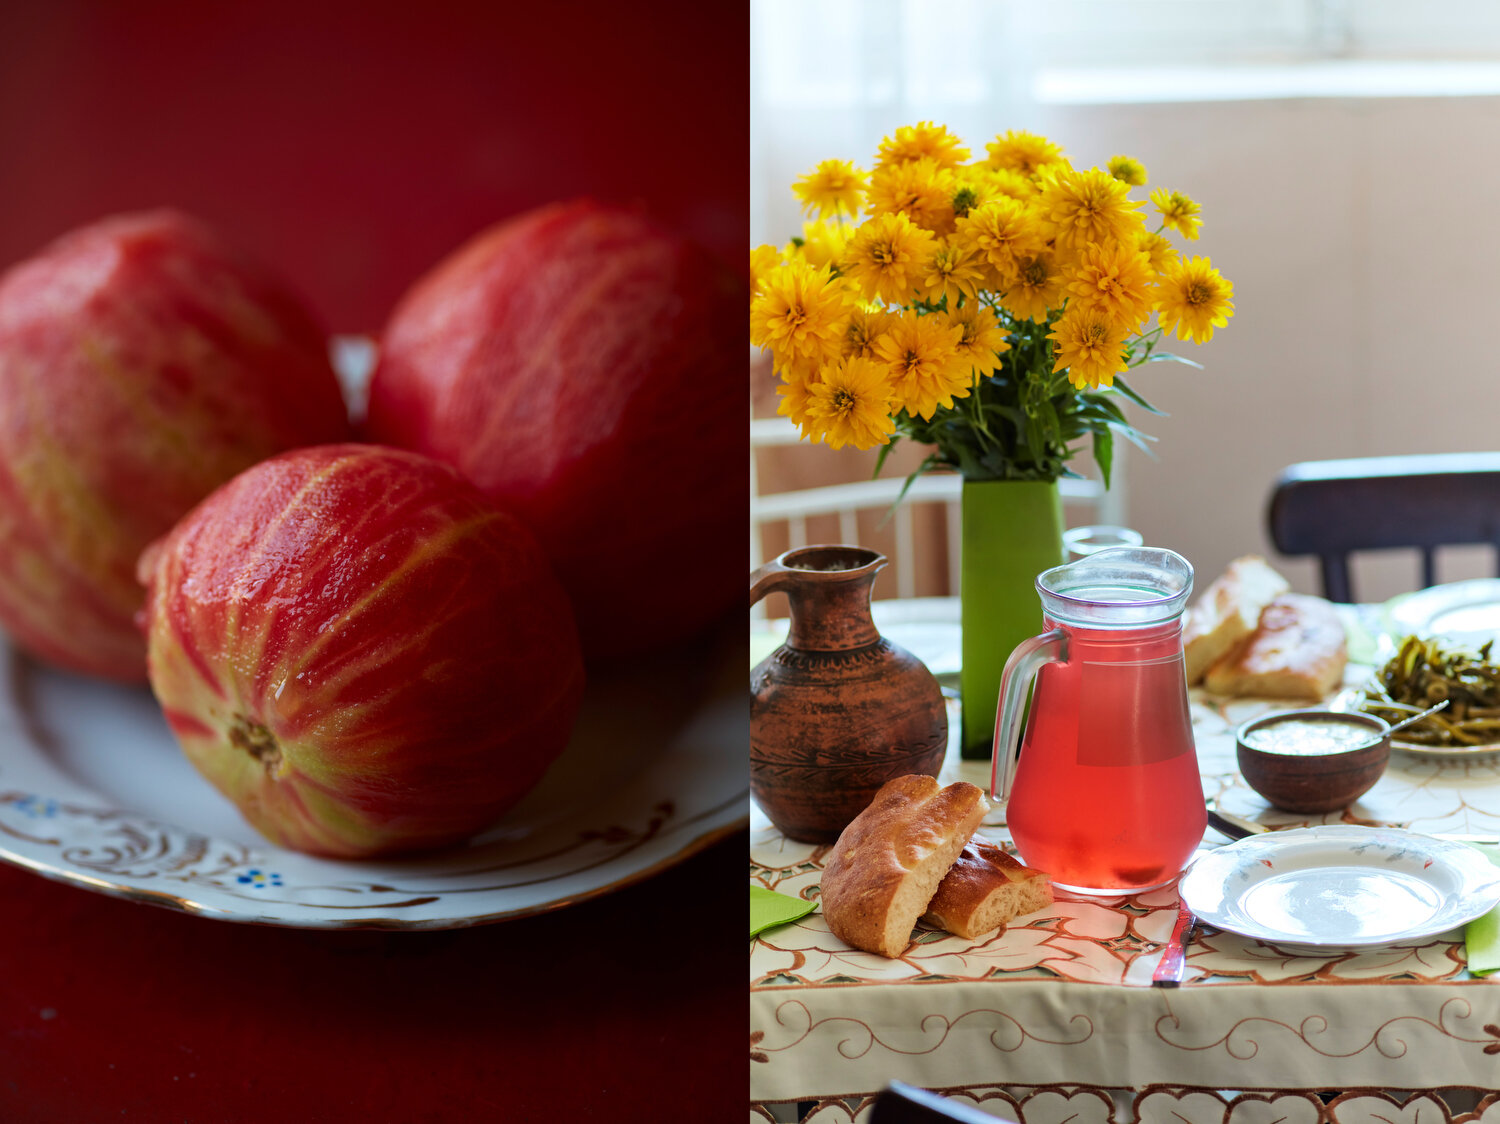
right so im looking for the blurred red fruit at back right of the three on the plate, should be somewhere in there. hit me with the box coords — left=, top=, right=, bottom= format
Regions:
left=368, top=201, right=749, bottom=659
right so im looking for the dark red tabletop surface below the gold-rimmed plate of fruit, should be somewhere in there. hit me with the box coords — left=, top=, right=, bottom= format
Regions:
left=0, top=834, right=749, bottom=1124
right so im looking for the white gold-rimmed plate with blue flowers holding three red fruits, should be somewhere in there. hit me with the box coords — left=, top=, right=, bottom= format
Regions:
left=0, top=630, right=749, bottom=929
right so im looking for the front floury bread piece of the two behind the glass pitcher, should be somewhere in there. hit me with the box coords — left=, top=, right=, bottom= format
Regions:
left=1203, top=593, right=1349, bottom=702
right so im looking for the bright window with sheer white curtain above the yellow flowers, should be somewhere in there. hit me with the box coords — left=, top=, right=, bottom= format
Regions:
left=750, top=0, right=1500, bottom=246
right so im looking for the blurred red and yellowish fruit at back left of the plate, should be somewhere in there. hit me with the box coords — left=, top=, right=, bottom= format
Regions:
left=0, top=210, right=350, bottom=681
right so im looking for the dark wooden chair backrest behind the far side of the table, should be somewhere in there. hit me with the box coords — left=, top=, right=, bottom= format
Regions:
left=1266, top=453, right=1500, bottom=602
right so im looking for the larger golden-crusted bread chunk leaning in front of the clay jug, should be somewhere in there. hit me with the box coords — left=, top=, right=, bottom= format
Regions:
left=821, top=774, right=990, bottom=957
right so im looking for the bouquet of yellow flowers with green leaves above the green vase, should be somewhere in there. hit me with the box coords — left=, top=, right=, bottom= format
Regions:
left=750, top=123, right=1233, bottom=486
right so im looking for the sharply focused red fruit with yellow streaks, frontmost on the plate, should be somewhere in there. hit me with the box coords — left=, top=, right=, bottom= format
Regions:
left=141, top=444, right=584, bottom=857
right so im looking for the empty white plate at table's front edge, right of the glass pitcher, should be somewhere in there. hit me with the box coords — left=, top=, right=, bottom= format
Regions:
left=1181, top=824, right=1500, bottom=948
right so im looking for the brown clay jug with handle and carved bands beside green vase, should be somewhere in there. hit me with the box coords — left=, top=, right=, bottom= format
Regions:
left=750, top=546, right=948, bottom=843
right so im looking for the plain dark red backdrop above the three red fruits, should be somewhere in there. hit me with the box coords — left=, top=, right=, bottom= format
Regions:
left=0, top=0, right=750, bottom=332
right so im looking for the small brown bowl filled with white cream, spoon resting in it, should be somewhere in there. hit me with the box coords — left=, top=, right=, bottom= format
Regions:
left=1235, top=710, right=1391, bottom=812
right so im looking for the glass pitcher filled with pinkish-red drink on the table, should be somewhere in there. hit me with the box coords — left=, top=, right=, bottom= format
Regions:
left=990, top=546, right=1208, bottom=894
